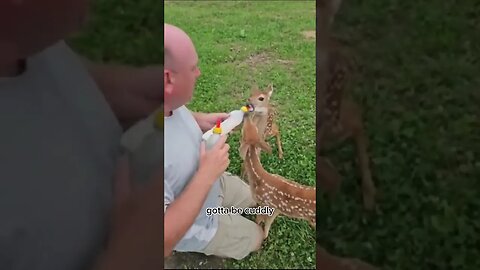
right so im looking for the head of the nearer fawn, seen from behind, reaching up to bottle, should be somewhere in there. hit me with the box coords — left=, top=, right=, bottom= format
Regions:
left=239, top=115, right=272, bottom=160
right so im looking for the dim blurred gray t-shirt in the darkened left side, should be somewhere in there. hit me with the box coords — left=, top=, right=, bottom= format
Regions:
left=0, top=42, right=121, bottom=270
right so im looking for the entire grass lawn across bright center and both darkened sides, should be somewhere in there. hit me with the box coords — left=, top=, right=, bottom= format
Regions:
left=65, top=0, right=480, bottom=270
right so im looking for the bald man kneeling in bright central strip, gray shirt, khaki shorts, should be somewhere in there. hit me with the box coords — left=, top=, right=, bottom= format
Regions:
left=164, top=24, right=263, bottom=260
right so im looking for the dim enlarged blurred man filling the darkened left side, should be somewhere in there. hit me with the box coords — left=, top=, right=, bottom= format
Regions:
left=0, top=0, right=167, bottom=270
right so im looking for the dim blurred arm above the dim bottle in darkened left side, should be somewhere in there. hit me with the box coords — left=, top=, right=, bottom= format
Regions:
left=82, top=57, right=163, bottom=129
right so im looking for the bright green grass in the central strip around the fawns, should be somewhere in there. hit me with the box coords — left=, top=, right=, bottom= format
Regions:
left=165, top=2, right=315, bottom=269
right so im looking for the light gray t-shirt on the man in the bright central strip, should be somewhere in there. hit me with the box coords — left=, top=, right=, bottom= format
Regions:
left=164, top=106, right=221, bottom=251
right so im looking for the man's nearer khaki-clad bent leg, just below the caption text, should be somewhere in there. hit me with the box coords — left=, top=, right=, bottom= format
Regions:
left=200, top=215, right=263, bottom=260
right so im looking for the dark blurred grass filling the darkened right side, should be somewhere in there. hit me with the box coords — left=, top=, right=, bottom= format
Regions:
left=317, top=0, right=480, bottom=270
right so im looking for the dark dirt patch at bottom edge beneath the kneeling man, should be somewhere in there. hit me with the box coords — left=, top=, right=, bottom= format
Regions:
left=164, top=252, right=225, bottom=269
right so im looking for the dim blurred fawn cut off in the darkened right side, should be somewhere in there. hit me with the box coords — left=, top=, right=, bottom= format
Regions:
left=317, top=0, right=376, bottom=210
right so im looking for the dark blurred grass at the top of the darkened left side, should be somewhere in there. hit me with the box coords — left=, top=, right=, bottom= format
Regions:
left=69, top=0, right=163, bottom=66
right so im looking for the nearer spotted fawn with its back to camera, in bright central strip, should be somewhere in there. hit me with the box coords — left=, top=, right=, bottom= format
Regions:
left=239, top=114, right=316, bottom=239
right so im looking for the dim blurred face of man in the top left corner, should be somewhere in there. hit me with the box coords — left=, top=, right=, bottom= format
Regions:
left=0, top=0, right=89, bottom=57
